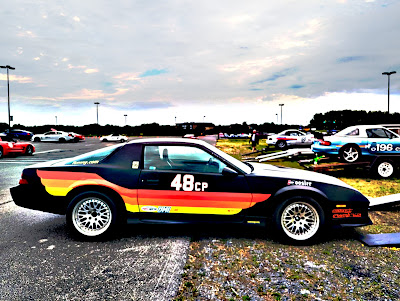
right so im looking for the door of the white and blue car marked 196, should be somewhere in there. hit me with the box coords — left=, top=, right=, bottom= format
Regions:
left=366, top=128, right=400, bottom=155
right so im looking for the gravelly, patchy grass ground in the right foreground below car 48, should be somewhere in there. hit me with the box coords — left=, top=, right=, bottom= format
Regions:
left=175, top=223, right=400, bottom=300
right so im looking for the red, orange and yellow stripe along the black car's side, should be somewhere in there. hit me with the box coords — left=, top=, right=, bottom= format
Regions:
left=37, top=170, right=271, bottom=215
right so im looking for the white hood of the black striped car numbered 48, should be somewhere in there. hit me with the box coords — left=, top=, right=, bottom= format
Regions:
left=251, top=163, right=358, bottom=191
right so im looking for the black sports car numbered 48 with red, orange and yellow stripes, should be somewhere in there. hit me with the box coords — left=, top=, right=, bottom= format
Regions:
left=11, top=139, right=371, bottom=242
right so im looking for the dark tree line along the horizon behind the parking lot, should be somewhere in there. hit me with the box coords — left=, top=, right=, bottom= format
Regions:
left=0, top=110, right=400, bottom=136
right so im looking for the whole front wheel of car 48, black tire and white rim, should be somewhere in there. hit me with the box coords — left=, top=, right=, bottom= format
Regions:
left=273, top=196, right=325, bottom=244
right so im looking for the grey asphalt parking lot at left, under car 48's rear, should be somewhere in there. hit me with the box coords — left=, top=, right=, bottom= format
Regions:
left=0, top=138, right=213, bottom=300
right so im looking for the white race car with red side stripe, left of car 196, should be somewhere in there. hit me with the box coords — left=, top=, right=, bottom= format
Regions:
left=267, top=130, right=314, bottom=149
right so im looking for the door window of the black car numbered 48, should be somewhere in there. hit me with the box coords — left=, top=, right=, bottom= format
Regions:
left=144, top=145, right=226, bottom=173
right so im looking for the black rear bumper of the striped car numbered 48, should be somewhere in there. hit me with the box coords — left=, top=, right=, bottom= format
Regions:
left=10, top=184, right=68, bottom=214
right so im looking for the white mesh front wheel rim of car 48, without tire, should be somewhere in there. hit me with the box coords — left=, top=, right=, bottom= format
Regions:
left=281, top=201, right=320, bottom=241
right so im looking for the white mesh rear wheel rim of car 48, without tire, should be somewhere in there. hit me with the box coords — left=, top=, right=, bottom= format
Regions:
left=72, top=197, right=112, bottom=236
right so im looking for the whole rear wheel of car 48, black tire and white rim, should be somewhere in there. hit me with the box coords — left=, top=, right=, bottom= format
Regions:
left=66, top=191, right=121, bottom=239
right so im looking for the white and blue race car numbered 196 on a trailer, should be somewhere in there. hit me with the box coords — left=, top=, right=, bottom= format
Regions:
left=312, top=125, right=400, bottom=163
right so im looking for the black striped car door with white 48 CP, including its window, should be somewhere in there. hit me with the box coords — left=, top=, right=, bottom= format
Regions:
left=138, top=144, right=252, bottom=221
